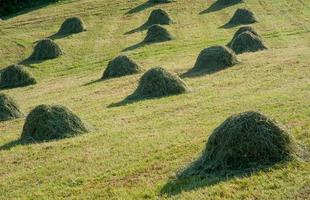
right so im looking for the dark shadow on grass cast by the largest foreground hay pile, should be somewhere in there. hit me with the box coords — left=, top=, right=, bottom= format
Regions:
left=160, top=160, right=285, bottom=197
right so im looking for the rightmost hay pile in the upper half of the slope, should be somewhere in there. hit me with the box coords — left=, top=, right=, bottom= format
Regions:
left=231, top=31, right=267, bottom=54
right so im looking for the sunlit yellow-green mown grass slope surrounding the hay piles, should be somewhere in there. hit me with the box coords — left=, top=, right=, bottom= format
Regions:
left=0, top=0, right=310, bottom=199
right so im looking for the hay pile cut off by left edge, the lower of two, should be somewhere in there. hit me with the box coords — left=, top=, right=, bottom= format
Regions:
left=0, top=93, right=23, bottom=121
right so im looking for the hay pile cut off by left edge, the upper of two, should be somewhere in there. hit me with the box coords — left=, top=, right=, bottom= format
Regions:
left=0, top=65, right=36, bottom=88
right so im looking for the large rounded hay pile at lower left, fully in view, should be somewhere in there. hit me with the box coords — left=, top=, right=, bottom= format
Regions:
left=21, top=105, right=88, bottom=141
